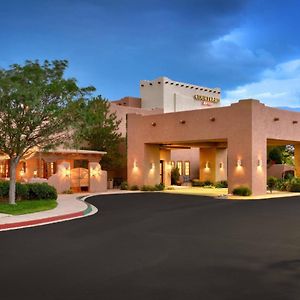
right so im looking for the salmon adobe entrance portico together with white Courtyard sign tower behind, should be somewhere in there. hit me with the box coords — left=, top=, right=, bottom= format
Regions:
left=124, top=77, right=300, bottom=195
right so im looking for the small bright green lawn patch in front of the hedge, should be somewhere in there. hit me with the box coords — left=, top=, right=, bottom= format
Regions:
left=0, top=200, right=57, bottom=215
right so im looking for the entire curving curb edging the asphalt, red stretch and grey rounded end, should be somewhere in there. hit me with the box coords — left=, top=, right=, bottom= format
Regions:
left=0, top=196, right=98, bottom=232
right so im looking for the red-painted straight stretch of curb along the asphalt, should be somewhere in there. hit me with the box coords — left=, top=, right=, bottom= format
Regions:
left=0, top=210, right=85, bottom=230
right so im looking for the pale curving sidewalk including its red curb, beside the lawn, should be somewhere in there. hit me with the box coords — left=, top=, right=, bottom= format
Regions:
left=0, top=194, right=98, bottom=231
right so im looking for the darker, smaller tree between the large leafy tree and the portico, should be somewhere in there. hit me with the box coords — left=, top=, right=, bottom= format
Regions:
left=73, top=96, right=122, bottom=169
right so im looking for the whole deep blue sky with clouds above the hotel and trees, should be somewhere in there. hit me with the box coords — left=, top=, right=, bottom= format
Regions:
left=0, top=0, right=300, bottom=107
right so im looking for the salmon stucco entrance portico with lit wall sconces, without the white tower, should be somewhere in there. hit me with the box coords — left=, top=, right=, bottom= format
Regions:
left=127, top=99, right=300, bottom=195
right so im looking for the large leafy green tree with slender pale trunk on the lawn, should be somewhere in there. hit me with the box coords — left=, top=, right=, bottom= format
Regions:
left=0, top=60, right=94, bottom=204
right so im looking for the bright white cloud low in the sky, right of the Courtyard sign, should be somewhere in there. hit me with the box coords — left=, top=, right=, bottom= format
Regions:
left=222, top=59, right=300, bottom=107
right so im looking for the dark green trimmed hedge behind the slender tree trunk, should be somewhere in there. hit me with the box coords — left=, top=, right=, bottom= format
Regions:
left=0, top=181, right=57, bottom=200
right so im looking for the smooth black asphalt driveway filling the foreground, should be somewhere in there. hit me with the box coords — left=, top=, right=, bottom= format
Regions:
left=0, top=193, right=300, bottom=300
